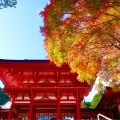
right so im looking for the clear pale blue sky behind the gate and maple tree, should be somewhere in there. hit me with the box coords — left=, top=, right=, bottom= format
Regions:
left=0, top=0, right=98, bottom=101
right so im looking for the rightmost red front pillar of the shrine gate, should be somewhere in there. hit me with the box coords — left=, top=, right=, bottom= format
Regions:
left=76, top=91, right=81, bottom=120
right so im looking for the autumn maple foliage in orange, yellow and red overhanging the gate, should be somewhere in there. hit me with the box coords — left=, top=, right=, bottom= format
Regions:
left=40, top=0, right=120, bottom=90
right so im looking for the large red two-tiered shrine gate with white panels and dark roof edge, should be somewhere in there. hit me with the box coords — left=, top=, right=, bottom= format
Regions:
left=0, top=60, right=90, bottom=120
